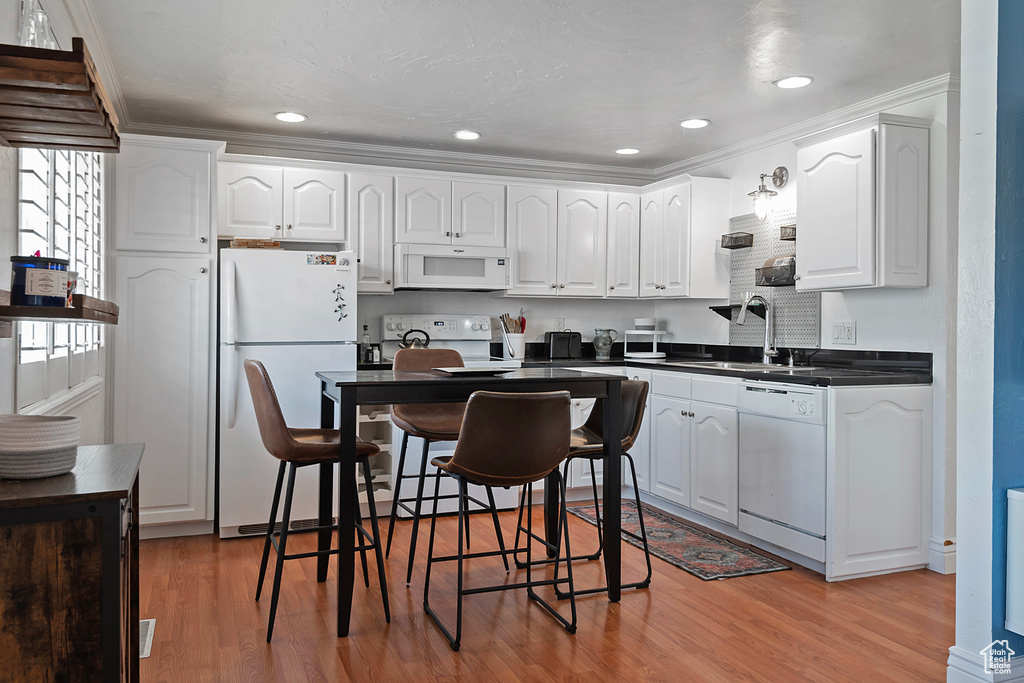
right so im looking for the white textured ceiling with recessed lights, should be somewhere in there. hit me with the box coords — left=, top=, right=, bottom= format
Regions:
left=91, top=0, right=959, bottom=169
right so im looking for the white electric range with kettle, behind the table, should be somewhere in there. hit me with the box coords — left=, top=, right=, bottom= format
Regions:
left=381, top=313, right=522, bottom=511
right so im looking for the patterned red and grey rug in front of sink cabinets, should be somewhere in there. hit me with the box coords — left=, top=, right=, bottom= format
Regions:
left=568, top=501, right=790, bottom=581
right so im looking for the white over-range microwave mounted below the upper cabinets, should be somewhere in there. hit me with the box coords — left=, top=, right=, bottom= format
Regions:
left=394, top=245, right=509, bottom=290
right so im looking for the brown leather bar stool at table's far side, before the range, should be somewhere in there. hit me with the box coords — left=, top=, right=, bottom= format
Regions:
left=384, top=348, right=509, bottom=585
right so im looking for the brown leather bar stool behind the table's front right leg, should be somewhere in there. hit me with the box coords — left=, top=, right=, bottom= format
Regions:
left=515, top=380, right=653, bottom=595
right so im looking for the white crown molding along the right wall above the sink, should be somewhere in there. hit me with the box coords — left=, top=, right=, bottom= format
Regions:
left=652, top=74, right=959, bottom=180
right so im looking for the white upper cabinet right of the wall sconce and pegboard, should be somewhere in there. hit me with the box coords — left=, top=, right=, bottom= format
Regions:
left=797, top=115, right=930, bottom=291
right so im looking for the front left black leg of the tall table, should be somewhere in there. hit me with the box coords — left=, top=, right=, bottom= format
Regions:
left=338, top=387, right=358, bottom=638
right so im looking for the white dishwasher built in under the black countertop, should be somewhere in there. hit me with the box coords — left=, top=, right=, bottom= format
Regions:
left=737, top=380, right=827, bottom=562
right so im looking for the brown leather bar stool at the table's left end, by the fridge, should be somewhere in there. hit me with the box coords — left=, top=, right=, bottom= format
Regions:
left=245, top=358, right=391, bottom=643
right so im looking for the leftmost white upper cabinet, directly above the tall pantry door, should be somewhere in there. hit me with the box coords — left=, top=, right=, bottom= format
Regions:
left=114, top=135, right=223, bottom=253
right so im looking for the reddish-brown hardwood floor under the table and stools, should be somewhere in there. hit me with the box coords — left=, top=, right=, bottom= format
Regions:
left=140, top=513, right=954, bottom=683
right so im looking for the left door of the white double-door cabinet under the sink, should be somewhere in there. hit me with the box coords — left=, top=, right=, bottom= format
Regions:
left=650, top=394, right=693, bottom=507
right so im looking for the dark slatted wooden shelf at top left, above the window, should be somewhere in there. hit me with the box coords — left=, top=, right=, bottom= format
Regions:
left=0, top=38, right=121, bottom=154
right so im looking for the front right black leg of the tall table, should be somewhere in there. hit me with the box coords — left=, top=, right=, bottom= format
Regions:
left=601, top=377, right=623, bottom=602
